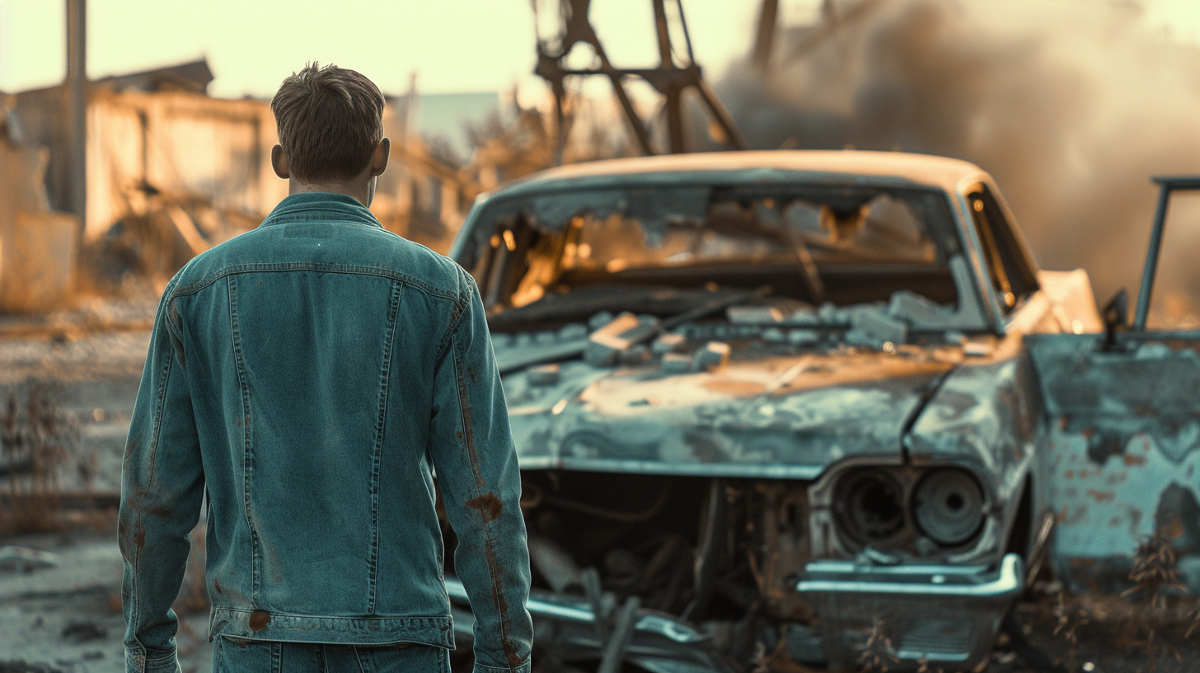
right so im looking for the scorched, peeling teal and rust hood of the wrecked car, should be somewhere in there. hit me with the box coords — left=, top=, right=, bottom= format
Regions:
left=504, top=347, right=961, bottom=479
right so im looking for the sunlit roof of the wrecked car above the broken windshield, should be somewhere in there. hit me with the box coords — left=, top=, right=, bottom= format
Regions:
left=492, top=150, right=983, bottom=196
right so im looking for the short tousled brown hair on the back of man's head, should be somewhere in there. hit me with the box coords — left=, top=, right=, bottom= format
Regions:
left=271, top=62, right=384, bottom=182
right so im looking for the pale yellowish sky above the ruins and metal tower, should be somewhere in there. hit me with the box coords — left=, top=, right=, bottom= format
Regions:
left=0, top=0, right=1200, bottom=97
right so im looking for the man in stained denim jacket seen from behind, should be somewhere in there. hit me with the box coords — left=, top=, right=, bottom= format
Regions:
left=119, top=64, right=533, bottom=673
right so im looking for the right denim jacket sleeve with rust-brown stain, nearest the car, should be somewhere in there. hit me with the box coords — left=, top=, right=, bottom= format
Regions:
left=430, top=270, right=533, bottom=673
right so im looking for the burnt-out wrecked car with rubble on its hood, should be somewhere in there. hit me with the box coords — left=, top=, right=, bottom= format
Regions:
left=446, top=151, right=1103, bottom=673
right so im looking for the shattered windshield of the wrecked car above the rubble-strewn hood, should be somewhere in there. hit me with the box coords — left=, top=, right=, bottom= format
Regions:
left=464, top=184, right=960, bottom=328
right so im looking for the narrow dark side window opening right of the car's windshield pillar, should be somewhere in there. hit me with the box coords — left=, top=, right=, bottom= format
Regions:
left=967, top=185, right=1038, bottom=313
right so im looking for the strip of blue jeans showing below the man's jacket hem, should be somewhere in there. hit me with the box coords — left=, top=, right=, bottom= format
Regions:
left=212, top=637, right=450, bottom=673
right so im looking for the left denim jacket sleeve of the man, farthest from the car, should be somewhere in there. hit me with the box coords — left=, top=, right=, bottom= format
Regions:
left=118, top=282, right=204, bottom=673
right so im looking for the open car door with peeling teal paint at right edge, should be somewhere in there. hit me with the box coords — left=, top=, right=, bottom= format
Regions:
left=1027, top=179, right=1200, bottom=593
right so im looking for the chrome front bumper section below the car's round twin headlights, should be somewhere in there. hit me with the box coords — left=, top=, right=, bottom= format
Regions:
left=796, top=554, right=1024, bottom=671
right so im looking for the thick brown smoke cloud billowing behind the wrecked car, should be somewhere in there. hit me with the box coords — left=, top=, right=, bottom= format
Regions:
left=718, top=0, right=1200, bottom=326
